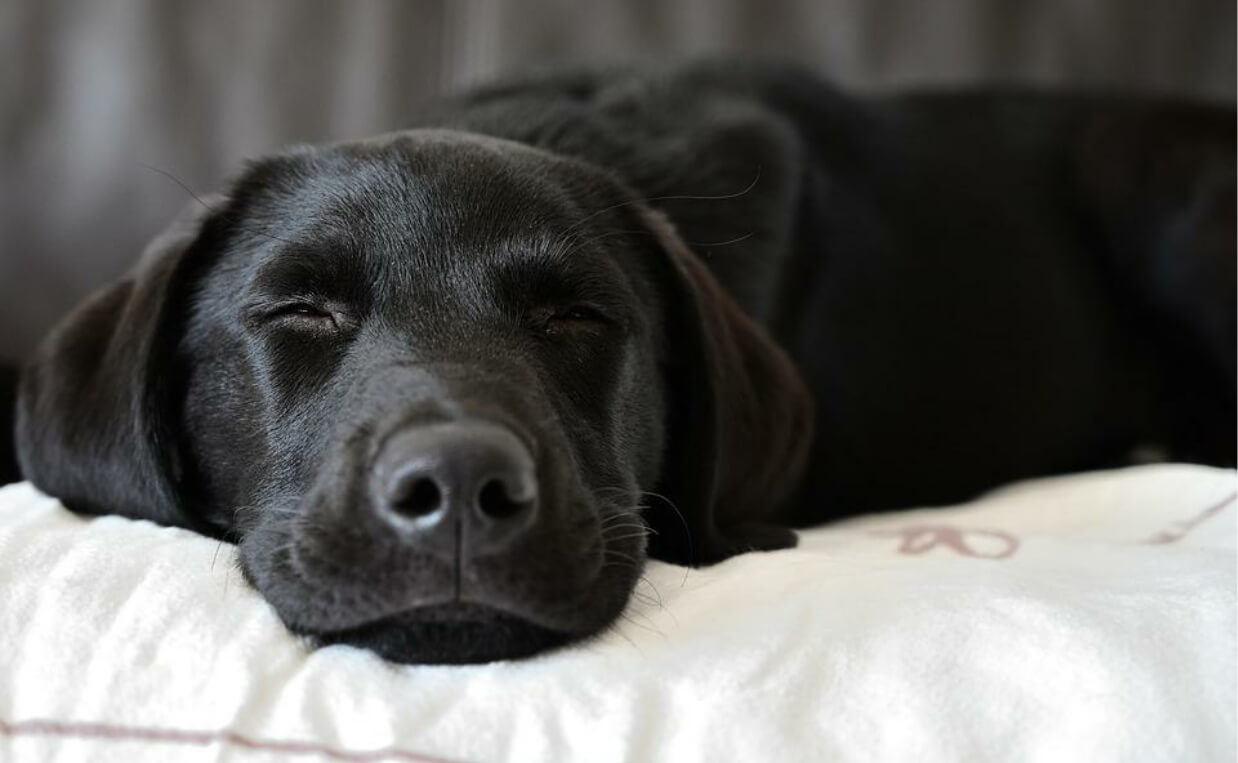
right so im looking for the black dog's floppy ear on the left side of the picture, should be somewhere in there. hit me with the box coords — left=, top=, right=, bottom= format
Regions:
left=16, top=199, right=222, bottom=529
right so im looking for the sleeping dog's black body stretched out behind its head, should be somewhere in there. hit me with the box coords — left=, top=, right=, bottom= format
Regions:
left=420, top=66, right=1234, bottom=523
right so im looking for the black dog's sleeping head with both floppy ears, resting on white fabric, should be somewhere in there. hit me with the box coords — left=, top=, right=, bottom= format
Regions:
left=19, top=130, right=811, bottom=661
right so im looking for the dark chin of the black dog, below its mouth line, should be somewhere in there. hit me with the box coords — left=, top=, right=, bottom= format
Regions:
left=306, top=603, right=583, bottom=665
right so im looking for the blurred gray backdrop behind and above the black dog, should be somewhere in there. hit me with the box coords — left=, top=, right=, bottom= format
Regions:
left=0, top=0, right=1236, bottom=358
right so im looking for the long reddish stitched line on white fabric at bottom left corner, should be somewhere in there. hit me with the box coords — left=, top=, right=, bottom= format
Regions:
left=0, top=718, right=463, bottom=763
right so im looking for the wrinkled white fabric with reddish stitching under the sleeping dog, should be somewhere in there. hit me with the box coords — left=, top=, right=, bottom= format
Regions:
left=0, top=466, right=1236, bottom=763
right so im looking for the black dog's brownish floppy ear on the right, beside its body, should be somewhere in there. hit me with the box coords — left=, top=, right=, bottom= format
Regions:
left=638, top=208, right=813, bottom=565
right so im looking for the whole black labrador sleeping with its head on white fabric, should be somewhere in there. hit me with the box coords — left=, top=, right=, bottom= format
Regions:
left=9, top=63, right=1236, bottom=663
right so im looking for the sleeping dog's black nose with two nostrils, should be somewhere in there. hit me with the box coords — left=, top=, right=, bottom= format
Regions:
left=374, top=421, right=537, bottom=556
